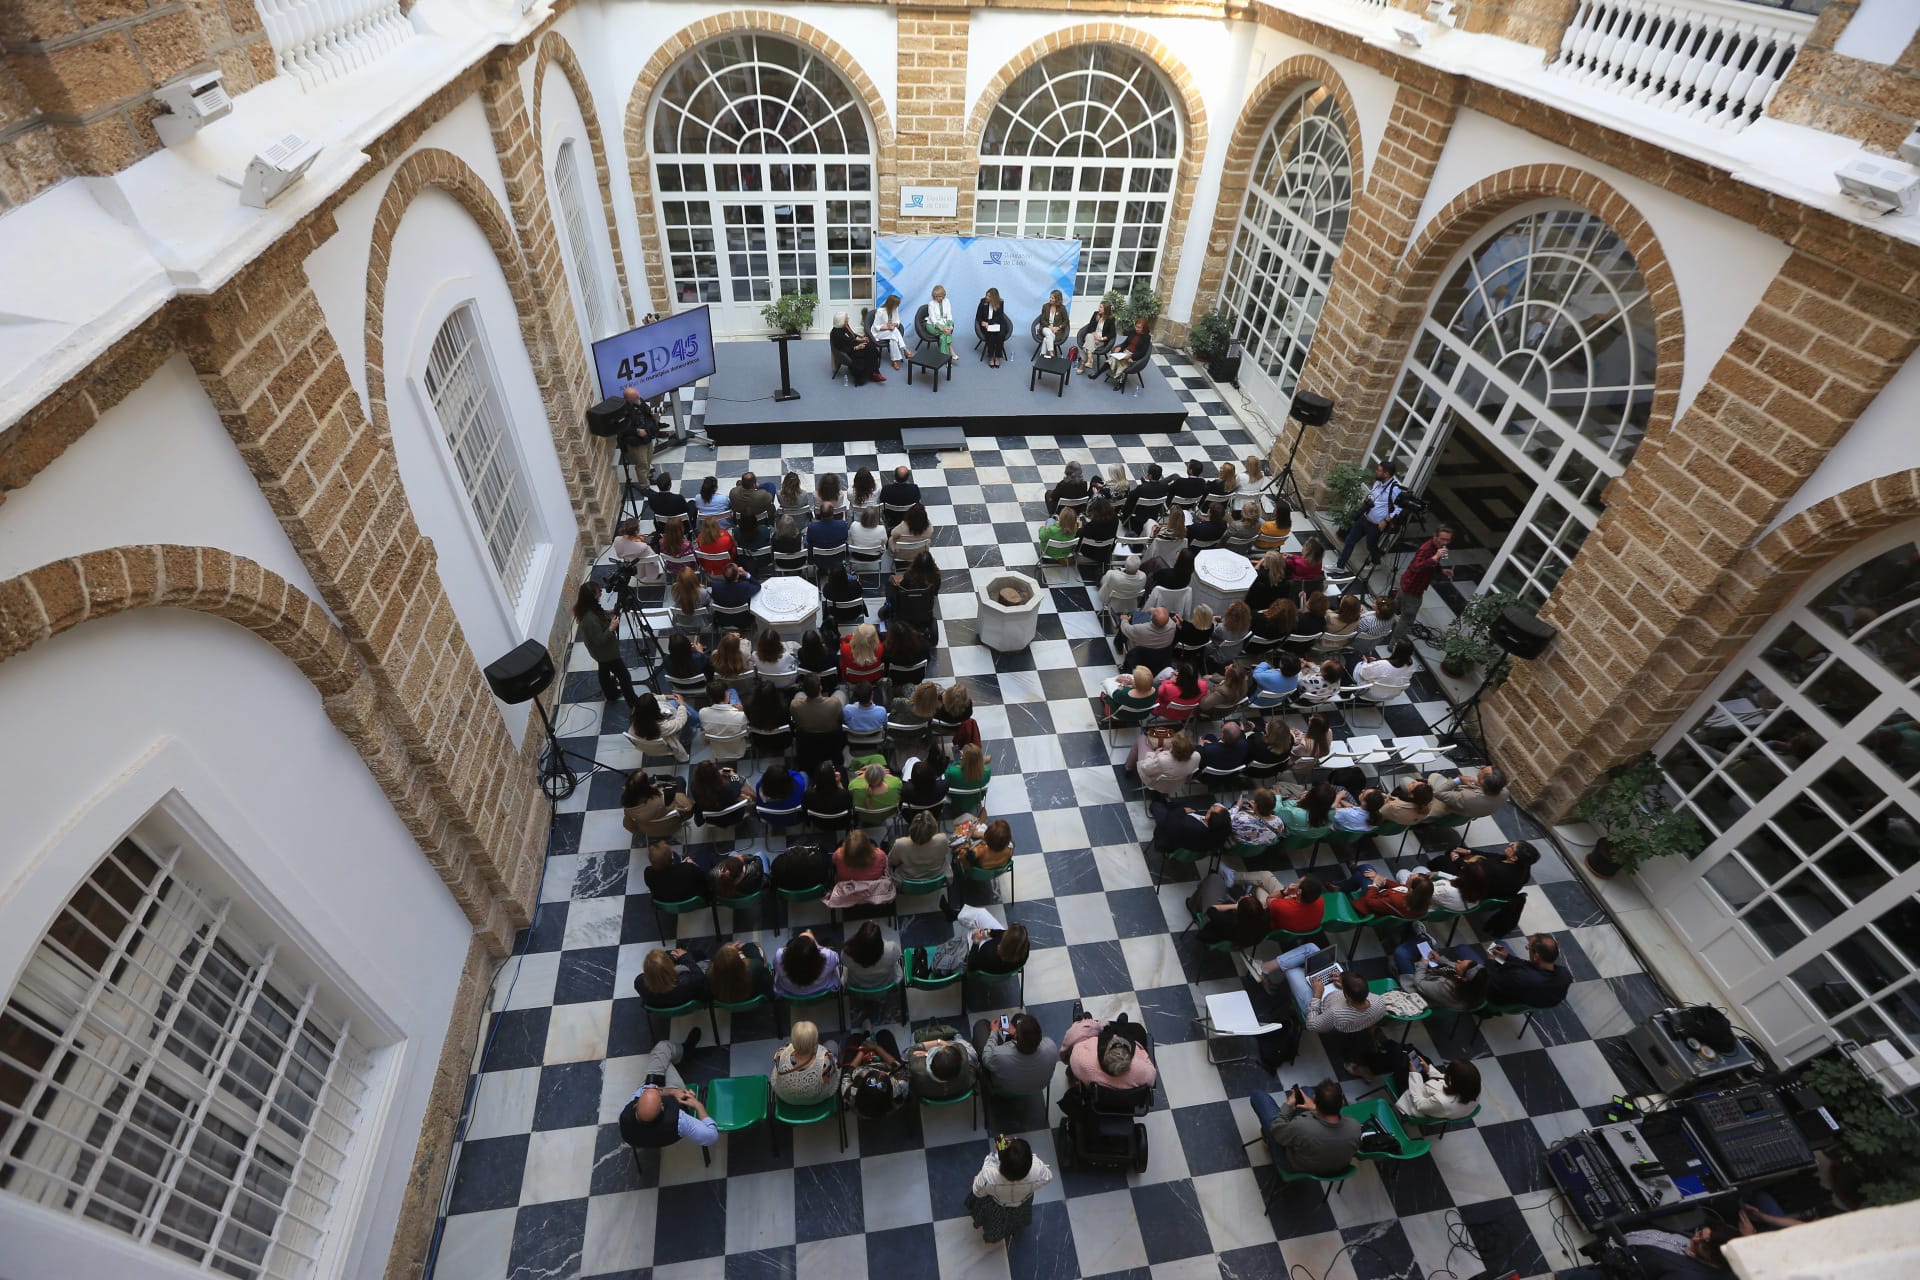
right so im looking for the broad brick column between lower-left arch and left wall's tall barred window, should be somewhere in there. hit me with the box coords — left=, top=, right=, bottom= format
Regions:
left=179, top=235, right=545, bottom=927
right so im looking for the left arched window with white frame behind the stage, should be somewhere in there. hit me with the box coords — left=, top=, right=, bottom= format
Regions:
left=653, top=35, right=874, bottom=332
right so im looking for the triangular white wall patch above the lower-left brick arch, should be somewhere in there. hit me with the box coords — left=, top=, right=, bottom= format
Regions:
left=0, top=355, right=321, bottom=603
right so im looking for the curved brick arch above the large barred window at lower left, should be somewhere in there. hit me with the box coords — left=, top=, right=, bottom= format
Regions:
left=0, top=543, right=516, bottom=956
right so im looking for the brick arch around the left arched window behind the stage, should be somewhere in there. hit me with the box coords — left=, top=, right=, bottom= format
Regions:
left=626, top=10, right=900, bottom=315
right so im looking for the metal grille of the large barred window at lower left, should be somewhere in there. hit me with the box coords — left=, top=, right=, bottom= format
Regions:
left=0, top=839, right=371, bottom=1280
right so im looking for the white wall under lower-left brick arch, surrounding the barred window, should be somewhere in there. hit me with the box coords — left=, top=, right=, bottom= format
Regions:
left=0, top=606, right=470, bottom=1280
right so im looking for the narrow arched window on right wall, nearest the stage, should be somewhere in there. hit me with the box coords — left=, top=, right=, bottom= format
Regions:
left=1221, top=84, right=1354, bottom=399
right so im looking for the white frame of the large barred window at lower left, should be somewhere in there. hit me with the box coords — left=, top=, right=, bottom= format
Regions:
left=0, top=805, right=382, bottom=1278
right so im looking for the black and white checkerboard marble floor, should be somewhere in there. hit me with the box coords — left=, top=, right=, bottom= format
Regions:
left=434, top=359, right=1667, bottom=1280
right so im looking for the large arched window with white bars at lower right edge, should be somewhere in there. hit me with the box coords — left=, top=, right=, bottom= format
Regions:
left=1653, top=526, right=1920, bottom=1057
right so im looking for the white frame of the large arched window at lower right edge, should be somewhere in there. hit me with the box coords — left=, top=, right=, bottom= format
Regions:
left=1640, top=522, right=1920, bottom=1059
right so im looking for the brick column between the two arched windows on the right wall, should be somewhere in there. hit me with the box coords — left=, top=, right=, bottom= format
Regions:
left=1273, top=75, right=1465, bottom=493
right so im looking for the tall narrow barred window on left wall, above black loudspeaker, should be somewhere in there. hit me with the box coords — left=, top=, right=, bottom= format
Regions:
left=426, top=303, right=538, bottom=606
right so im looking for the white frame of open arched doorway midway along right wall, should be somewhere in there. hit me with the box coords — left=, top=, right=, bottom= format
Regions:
left=1369, top=201, right=1657, bottom=604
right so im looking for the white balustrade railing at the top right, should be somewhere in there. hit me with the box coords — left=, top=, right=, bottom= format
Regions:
left=1551, top=0, right=1814, bottom=130
